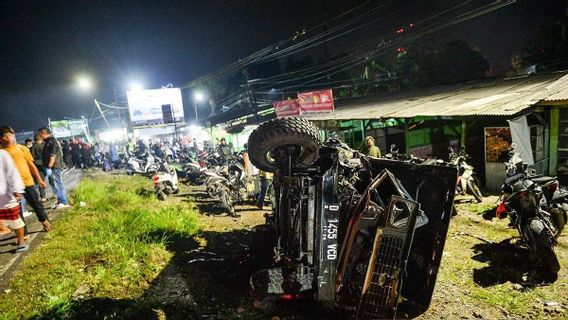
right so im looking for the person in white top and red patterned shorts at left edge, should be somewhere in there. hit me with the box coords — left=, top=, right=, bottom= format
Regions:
left=0, top=150, right=28, bottom=252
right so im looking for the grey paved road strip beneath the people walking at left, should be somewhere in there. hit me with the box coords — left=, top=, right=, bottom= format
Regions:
left=0, top=170, right=83, bottom=290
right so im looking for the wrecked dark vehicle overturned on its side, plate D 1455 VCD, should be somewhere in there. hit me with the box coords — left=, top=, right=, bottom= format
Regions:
left=249, top=118, right=457, bottom=319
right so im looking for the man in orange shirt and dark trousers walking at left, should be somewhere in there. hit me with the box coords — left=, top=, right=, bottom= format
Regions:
left=0, top=126, right=53, bottom=235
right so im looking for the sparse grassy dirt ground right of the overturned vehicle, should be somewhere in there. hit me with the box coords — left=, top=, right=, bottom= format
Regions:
left=424, top=203, right=568, bottom=319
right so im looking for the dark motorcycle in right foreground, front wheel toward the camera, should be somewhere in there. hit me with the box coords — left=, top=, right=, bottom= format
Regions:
left=495, top=174, right=560, bottom=275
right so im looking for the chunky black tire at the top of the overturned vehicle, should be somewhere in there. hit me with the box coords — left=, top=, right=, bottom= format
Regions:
left=248, top=118, right=321, bottom=172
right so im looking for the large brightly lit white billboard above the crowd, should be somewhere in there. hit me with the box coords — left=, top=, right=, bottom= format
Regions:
left=126, top=88, right=184, bottom=127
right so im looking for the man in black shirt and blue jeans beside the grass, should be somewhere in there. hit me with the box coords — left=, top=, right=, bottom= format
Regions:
left=39, top=128, right=69, bottom=209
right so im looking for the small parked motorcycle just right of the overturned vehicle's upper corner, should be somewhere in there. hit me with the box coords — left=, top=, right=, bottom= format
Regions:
left=448, top=147, right=483, bottom=202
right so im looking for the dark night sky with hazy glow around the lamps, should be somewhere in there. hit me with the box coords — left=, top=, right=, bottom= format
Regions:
left=0, top=0, right=562, bottom=130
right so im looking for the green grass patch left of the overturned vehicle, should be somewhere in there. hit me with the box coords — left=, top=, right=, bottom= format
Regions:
left=0, top=175, right=198, bottom=319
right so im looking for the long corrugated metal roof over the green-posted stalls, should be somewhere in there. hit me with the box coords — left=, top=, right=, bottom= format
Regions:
left=302, top=73, right=568, bottom=120
